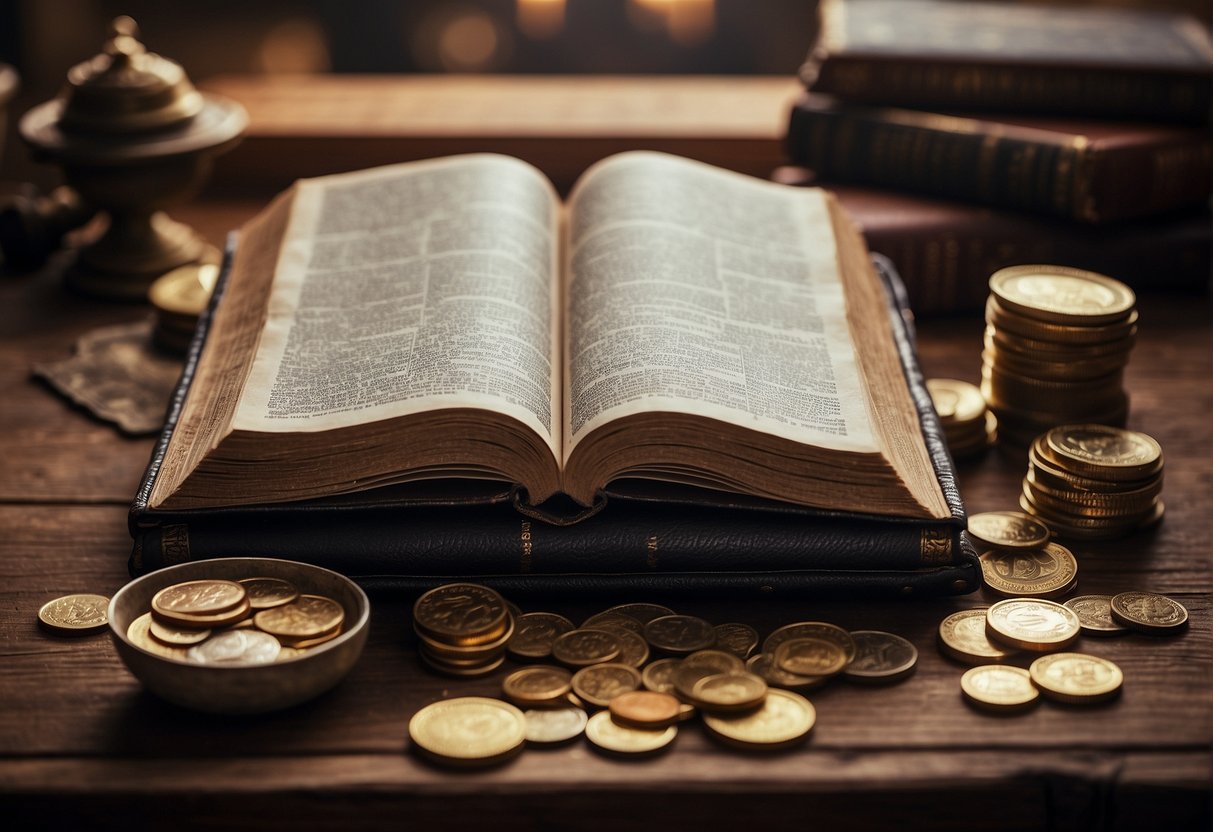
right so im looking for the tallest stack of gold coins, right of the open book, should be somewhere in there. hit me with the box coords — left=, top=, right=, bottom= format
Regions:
left=981, top=266, right=1138, bottom=446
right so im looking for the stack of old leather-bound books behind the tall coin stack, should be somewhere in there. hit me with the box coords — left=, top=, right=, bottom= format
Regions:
left=787, top=0, right=1213, bottom=313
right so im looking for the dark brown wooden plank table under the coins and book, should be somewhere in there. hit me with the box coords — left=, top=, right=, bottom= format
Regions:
left=0, top=80, right=1213, bottom=832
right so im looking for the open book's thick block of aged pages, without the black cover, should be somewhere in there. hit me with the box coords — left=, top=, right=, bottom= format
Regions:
left=148, top=153, right=953, bottom=519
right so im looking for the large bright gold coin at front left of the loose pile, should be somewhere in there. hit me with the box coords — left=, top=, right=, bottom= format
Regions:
left=409, top=696, right=526, bottom=764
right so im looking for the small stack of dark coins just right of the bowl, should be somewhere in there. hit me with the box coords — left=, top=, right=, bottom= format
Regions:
left=412, top=583, right=514, bottom=676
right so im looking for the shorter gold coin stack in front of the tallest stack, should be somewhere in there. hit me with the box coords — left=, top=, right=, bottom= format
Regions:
left=1019, top=424, right=1164, bottom=540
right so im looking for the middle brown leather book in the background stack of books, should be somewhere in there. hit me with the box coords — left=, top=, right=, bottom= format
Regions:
left=787, top=95, right=1213, bottom=223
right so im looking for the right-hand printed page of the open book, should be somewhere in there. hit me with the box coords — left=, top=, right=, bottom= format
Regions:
left=564, top=153, right=878, bottom=458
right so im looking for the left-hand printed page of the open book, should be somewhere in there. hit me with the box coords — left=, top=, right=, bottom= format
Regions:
left=234, top=155, right=560, bottom=458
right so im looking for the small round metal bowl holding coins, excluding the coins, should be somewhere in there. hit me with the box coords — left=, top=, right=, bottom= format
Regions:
left=109, top=558, right=370, bottom=713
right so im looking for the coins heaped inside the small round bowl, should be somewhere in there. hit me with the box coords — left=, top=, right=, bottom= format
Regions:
left=126, top=577, right=346, bottom=666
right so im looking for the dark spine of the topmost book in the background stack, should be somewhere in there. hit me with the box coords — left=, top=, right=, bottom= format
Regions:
left=802, top=55, right=1213, bottom=124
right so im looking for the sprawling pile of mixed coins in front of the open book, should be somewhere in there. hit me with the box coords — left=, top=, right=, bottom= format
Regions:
left=409, top=583, right=918, bottom=764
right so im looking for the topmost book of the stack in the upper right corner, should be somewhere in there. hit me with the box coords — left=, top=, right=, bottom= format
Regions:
left=801, top=0, right=1213, bottom=124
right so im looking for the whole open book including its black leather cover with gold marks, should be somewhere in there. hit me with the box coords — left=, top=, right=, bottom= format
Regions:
left=131, top=153, right=976, bottom=592
